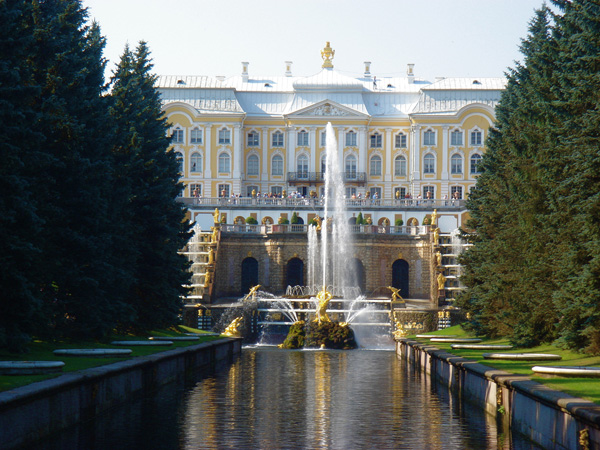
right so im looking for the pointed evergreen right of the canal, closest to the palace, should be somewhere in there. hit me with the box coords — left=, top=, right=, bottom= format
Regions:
left=460, top=7, right=557, bottom=346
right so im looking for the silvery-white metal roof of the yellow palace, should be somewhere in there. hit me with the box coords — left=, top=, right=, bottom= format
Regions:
left=157, top=49, right=506, bottom=118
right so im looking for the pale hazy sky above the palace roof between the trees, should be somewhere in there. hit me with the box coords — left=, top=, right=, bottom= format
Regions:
left=83, top=0, right=543, bottom=81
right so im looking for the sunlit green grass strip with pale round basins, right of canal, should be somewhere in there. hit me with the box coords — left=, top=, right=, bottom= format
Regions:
left=411, top=325, right=600, bottom=404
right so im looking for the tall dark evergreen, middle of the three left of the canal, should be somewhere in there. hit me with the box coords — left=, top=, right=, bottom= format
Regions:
left=31, top=0, right=119, bottom=337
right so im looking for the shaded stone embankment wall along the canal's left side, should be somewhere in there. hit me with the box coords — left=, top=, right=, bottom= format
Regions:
left=0, top=338, right=242, bottom=449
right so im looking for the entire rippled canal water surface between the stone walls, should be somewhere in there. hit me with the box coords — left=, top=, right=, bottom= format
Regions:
left=29, top=347, right=540, bottom=450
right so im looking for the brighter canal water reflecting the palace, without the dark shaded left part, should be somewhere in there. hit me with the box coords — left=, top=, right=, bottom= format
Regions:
left=183, top=349, right=537, bottom=449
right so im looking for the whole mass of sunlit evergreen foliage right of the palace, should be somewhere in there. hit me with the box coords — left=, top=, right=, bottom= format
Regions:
left=459, top=0, right=600, bottom=353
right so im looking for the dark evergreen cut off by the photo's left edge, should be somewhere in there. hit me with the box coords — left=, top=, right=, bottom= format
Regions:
left=0, top=0, right=43, bottom=351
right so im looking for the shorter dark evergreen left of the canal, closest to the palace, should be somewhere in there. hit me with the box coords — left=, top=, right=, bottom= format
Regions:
left=111, top=42, right=190, bottom=329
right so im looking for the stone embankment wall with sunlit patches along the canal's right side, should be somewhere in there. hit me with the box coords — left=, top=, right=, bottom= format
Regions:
left=396, top=339, right=600, bottom=450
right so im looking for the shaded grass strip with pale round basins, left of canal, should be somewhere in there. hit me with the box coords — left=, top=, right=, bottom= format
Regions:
left=0, top=325, right=219, bottom=392
